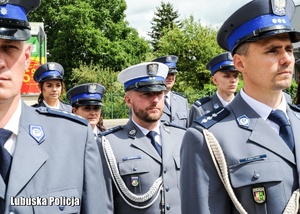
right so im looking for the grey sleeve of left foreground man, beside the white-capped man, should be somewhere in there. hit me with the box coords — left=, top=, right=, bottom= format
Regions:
left=81, top=128, right=108, bottom=214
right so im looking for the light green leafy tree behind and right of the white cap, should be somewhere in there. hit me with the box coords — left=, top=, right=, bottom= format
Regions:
left=155, top=16, right=224, bottom=103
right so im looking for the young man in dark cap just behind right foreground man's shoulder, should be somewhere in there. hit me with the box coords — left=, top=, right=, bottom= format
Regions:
left=189, top=52, right=239, bottom=126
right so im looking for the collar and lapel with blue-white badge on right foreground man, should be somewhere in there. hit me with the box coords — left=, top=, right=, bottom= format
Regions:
left=228, top=94, right=295, bottom=164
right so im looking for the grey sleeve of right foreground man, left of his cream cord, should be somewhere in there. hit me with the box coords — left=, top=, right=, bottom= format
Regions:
left=180, top=128, right=231, bottom=214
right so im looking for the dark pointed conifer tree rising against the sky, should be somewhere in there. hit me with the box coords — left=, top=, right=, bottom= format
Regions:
left=148, top=2, right=181, bottom=51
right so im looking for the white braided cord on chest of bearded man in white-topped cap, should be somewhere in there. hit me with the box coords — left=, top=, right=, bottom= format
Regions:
left=101, top=136, right=162, bottom=209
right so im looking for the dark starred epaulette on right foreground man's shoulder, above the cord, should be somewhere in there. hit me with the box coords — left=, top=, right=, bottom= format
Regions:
left=195, top=107, right=230, bottom=129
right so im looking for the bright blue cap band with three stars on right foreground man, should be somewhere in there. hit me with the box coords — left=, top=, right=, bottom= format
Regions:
left=227, top=14, right=291, bottom=51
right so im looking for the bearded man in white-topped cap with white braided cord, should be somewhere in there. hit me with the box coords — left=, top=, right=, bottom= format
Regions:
left=99, top=62, right=185, bottom=214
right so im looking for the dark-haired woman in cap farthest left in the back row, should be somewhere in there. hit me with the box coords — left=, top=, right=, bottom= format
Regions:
left=32, top=62, right=72, bottom=112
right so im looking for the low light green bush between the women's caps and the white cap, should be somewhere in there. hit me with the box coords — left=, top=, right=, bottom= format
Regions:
left=70, top=63, right=129, bottom=119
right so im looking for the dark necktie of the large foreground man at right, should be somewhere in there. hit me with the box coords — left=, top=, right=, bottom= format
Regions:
left=268, top=110, right=295, bottom=151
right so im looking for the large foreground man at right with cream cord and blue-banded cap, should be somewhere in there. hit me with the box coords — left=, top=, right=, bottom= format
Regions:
left=180, top=0, right=300, bottom=214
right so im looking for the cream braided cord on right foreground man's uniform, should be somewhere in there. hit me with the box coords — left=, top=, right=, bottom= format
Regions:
left=203, top=129, right=300, bottom=214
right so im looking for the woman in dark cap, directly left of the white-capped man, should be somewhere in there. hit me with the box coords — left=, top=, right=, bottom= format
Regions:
left=67, top=83, right=106, bottom=135
